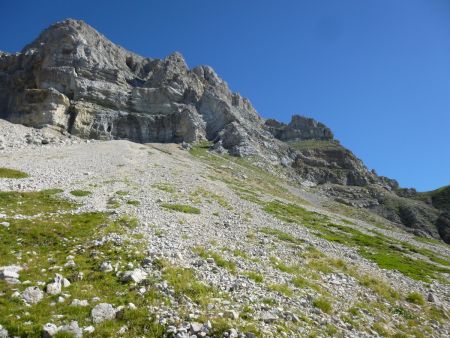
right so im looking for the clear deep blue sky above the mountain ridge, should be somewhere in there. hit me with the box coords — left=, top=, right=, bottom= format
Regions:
left=0, top=0, right=450, bottom=190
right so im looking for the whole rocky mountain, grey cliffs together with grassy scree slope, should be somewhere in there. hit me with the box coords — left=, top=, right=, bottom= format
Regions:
left=0, top=20, right=450, bottom=338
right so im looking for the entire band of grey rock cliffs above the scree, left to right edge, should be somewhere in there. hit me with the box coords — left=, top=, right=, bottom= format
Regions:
left=0, top=20, right=449, bottom=241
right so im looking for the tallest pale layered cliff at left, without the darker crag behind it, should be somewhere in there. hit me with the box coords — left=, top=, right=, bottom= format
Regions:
left=0, top=20, right=284, bottom=159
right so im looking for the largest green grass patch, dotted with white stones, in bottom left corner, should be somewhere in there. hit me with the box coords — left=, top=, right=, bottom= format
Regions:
left=0, top=191, right=170, bottom=337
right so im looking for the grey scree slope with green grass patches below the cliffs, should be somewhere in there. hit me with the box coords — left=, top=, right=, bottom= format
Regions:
left=0, top=120, right=450, bottom=337
